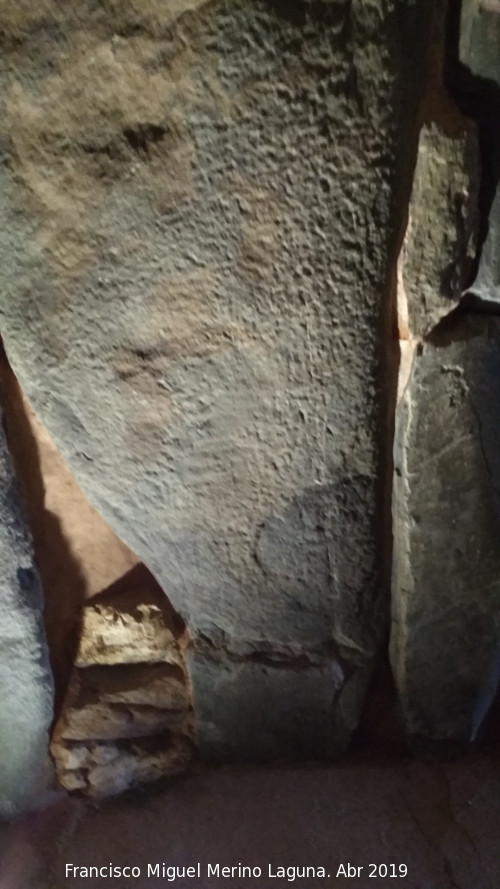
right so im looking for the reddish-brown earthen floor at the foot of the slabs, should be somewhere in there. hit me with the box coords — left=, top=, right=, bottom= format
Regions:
left=0, top=758, right=500, bottom=889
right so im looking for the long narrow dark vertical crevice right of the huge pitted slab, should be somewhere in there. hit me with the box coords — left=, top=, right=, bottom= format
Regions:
left=370, top=0, right=443, bottom=759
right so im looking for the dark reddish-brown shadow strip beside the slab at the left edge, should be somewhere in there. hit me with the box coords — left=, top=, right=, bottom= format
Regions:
left=0, top=341, right=85, bottom=718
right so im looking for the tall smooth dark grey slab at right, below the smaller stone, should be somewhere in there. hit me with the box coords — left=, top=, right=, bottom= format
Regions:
left=391, top=315, right=500, bottom=741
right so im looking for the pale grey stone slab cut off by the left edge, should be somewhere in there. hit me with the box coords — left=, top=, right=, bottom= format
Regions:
left=0, top=426, right=53, bottom=818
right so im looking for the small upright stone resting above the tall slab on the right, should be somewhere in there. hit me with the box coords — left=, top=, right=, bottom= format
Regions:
left=398, top=121, right=481, bottom=339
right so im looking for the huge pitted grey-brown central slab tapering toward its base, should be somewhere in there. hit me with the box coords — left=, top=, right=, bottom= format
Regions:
left=0, top=0, right=429, bottom=758
